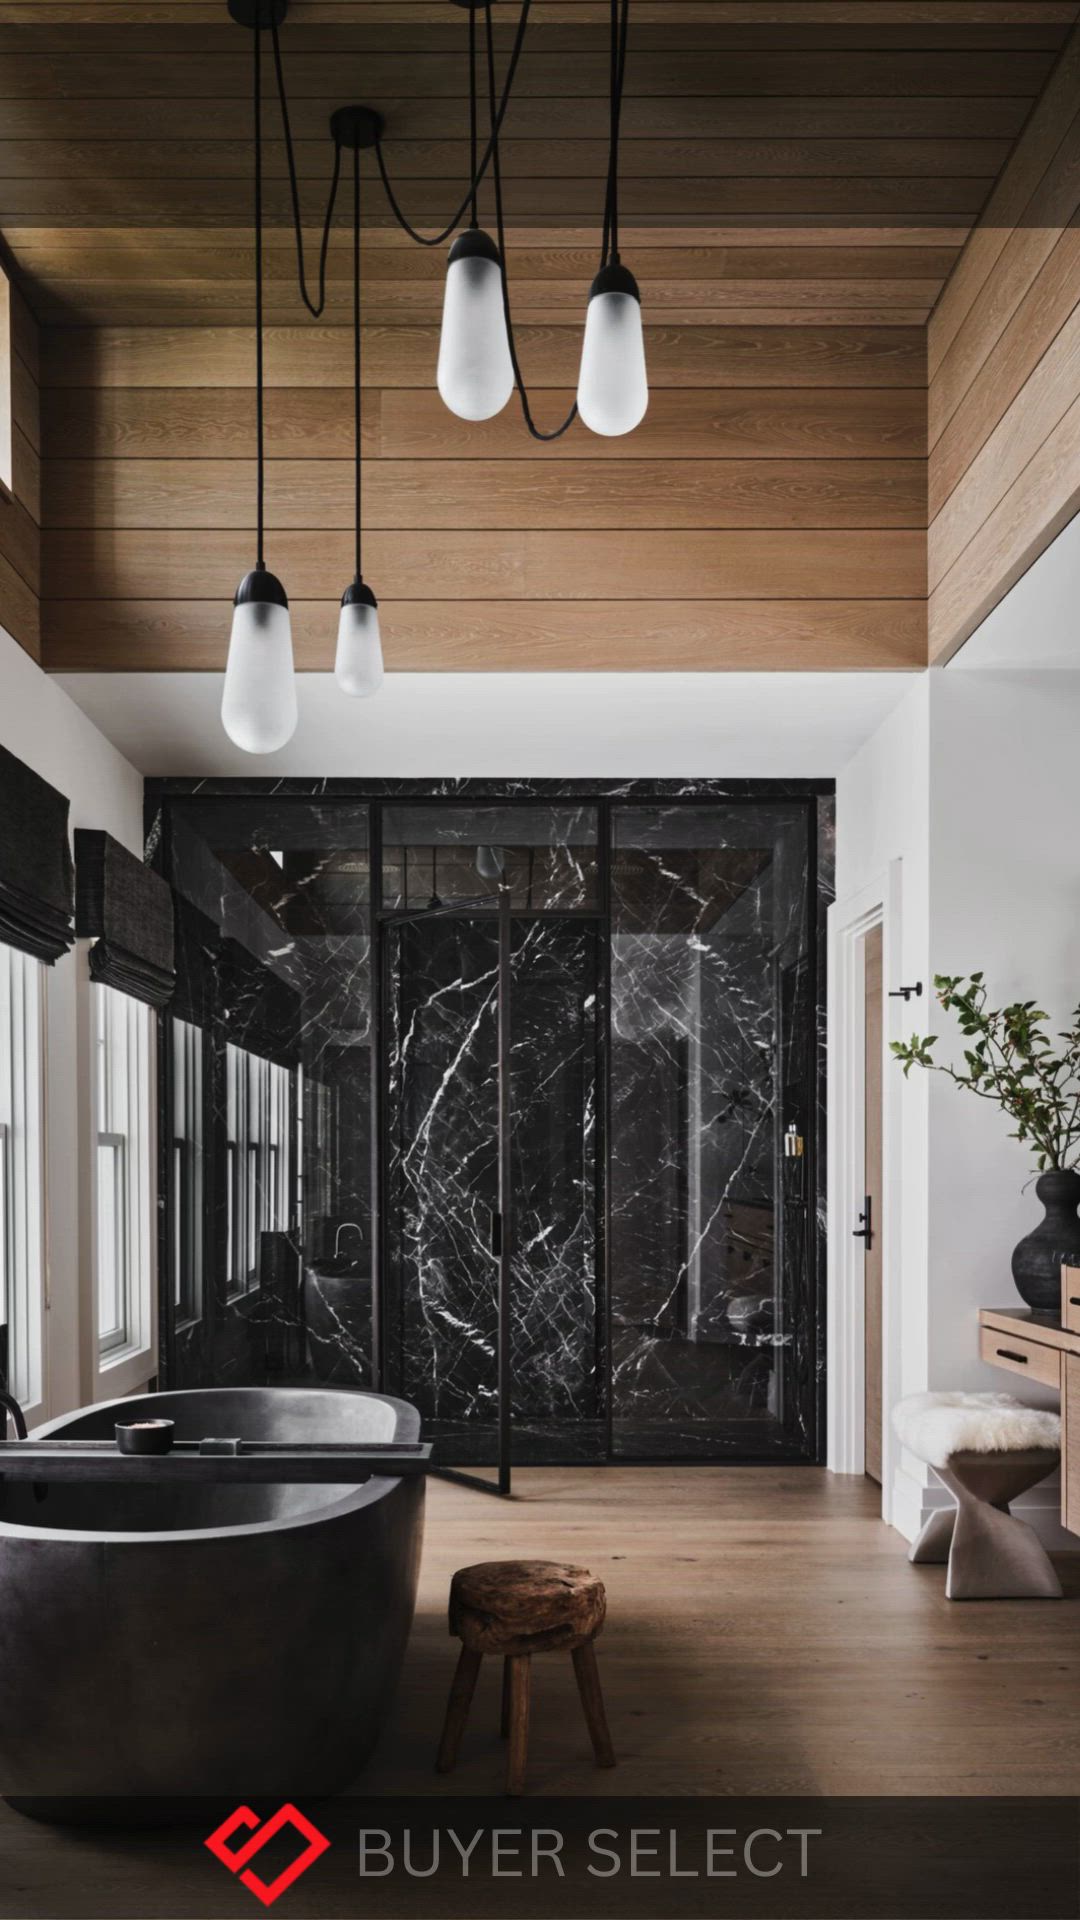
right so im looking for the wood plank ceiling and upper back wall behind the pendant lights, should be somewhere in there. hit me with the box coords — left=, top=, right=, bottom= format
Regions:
left=0, top=0, right=1080, bottom=668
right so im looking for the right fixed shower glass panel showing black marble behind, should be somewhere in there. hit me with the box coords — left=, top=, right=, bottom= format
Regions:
left=609, top=804, right=815, bottom=1455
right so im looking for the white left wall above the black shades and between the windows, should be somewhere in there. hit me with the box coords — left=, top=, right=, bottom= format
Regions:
left=0, top=628, right=142, bottom=1415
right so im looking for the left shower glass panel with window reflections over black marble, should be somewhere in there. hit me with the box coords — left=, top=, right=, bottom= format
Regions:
left=161, top=795, right=375, bottom=1386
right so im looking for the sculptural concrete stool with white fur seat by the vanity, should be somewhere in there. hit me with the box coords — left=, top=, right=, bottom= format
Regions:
left=892, top=1394, right=1061, bottom=1599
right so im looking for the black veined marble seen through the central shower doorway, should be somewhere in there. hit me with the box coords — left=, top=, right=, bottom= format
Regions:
left=384, top=918, right=598, bottom=1461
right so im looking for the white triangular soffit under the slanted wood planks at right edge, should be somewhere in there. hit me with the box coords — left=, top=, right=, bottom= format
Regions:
left=949, top=515, right=1080, bottom=670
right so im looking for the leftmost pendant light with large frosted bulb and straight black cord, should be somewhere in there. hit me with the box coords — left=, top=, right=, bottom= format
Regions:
left=221, top=0, right=298, bottom=753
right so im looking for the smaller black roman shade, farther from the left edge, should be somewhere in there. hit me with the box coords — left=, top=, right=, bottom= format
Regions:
left=75, top=829, right=177, bottom=1006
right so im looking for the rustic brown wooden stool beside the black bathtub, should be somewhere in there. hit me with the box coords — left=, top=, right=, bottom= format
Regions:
left=436, top=1561, right=615, bottom=1793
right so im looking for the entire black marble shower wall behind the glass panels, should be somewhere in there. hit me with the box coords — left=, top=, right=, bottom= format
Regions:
left=148, top=781, right=832, bottom=1463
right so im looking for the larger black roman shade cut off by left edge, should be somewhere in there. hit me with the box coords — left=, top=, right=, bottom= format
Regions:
left=0, top=747, right=75, bottom=966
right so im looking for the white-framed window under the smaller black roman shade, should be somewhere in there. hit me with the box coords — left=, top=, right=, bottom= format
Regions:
left=90, top=985, right=154, bottom=1363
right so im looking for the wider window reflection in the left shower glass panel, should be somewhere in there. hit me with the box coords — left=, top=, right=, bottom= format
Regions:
left=225, top=1044, right=292, bottom=1300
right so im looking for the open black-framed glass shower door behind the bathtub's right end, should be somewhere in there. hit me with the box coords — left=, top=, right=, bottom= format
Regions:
left=379, top=887, right=513, bottom=1494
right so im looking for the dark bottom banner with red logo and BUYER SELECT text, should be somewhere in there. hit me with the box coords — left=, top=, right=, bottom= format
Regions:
left=0, top=1793, right=1080, bottom=1920
